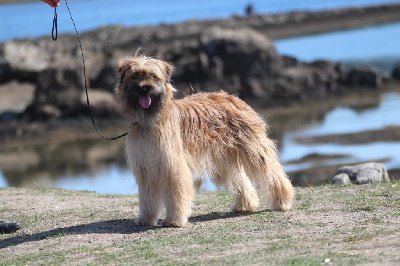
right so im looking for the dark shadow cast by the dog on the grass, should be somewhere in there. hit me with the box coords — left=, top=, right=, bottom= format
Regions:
left=0, top=211, right=265, bottom=249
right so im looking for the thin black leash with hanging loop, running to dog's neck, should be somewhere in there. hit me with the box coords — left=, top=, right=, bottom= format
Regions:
left=51, top=0, right=136, bottom=140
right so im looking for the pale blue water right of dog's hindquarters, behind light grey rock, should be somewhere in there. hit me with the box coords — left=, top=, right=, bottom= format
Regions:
left=280, top=92, right=400, bottom=171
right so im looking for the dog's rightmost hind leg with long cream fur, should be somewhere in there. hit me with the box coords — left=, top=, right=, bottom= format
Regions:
left=244, top=134, right=294, bottom=211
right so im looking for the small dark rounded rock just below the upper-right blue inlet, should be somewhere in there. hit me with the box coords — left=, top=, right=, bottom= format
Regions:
left=345, top=68, right=383, bottom=88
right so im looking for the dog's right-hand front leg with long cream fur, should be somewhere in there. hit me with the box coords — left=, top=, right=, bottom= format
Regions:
left=162, top=160, right=194, bottom=227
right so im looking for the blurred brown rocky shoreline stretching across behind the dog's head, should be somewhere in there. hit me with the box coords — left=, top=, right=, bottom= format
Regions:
left=0, top=4, right=400, bottom=121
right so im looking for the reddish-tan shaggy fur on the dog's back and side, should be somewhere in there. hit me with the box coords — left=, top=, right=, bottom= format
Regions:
left=174, top=92, right=267, bottom=152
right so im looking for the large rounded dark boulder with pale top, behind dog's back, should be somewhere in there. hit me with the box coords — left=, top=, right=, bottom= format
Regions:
left=200, top=27, right=283, bottom=98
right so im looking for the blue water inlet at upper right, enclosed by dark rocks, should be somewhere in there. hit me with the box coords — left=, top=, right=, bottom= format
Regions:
left=275, top=23, right=400, bottom=61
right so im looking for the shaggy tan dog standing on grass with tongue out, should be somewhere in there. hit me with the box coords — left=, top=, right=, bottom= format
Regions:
left=115, top=54, right=294, bottom=227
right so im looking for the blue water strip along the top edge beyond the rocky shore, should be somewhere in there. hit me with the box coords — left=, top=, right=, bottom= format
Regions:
left=0, top=0, right=400, bottom=41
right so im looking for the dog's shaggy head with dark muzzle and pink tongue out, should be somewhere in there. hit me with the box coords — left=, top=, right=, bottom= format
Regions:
left=115, top=55, right=173, bottom=124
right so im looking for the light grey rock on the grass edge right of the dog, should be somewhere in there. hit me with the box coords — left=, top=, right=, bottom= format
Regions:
left=331, top=162, right=390, bottom=185
